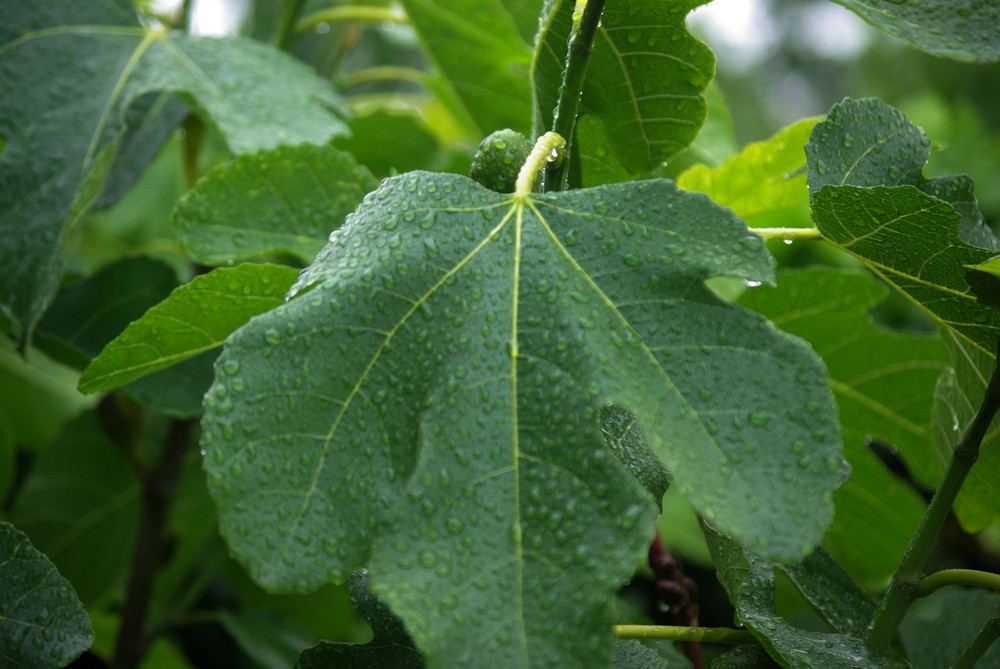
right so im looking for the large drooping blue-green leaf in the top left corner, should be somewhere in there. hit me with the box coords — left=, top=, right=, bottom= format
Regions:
left=0, top=0, right=346, bottom=348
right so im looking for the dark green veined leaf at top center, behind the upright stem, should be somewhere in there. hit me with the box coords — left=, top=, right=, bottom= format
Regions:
left=532, top=0, right=715, bottom=185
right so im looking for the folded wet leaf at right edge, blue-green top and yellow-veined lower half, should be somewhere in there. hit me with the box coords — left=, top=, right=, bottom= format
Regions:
left=806, top=99, right=1000, bottom=355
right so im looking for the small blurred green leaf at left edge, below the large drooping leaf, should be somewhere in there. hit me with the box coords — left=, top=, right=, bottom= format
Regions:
left=0, top=337, right=96, bottom=449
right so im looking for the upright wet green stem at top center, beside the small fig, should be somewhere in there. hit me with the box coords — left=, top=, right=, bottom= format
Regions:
left=543, top=0, right=606, bottom=191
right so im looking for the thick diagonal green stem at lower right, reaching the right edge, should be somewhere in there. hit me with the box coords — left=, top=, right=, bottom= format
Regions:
left=864, top=342, right=1000, bottom=655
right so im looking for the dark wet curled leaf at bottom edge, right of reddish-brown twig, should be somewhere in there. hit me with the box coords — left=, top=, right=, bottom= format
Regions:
left=706, top=529, right=909, bottom=669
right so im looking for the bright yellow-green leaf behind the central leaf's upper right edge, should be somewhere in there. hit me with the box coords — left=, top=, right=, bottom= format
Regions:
left=677, top=119, right=819, bottom=218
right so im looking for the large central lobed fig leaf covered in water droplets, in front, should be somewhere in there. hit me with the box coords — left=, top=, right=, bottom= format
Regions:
left=202, top=173, right=842, bottom=667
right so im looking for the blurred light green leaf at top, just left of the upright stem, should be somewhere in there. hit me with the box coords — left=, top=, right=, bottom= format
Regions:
left=401, top=0, right=531, bottom=136
